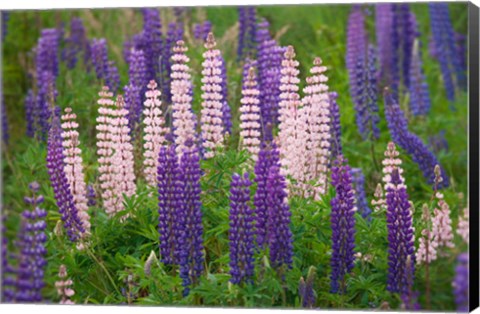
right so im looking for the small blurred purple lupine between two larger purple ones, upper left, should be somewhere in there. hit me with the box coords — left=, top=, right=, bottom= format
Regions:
left=63, top=17, right=88, bottom=69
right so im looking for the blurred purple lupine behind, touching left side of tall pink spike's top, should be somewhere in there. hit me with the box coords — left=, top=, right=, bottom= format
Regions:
left=161, top=23, right=183, bottom=104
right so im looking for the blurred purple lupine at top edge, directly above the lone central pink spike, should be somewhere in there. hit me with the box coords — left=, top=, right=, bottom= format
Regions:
left=237, top=6, right=257, bottom=60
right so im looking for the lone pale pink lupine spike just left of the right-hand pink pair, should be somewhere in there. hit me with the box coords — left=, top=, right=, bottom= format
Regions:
left=240, top=67, right=261, bottom=160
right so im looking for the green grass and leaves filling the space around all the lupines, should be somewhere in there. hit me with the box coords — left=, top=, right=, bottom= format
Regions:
left=2, top=4, right=467, bottom=310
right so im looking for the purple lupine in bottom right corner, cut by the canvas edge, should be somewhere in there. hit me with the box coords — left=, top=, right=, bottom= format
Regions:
left=452, top=253, right=469, bottom=313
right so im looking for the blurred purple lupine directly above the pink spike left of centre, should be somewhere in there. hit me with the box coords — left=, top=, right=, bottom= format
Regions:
left=142, top=8, right=163, bottom=82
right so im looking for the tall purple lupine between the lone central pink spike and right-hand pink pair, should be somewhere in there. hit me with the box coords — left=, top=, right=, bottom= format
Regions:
left=255, top=20, right=285, bottom=142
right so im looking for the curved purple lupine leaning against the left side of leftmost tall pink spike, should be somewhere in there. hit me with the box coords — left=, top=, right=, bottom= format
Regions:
left=47, top=115, right=85, bottom=241
